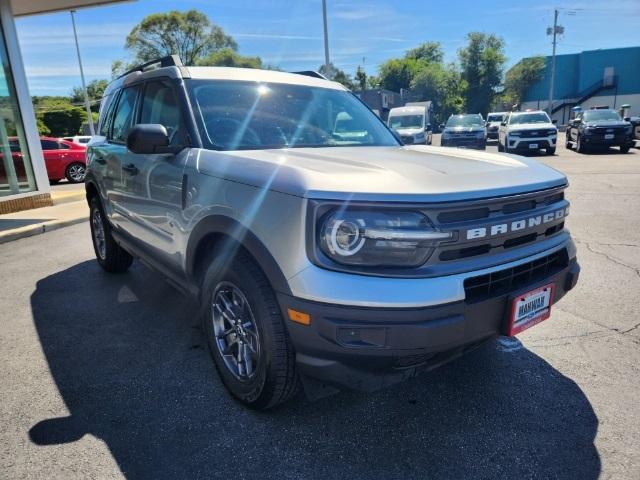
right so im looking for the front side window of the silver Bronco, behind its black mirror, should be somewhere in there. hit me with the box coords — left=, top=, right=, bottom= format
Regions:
left=140, top=81, right=182, bottom=144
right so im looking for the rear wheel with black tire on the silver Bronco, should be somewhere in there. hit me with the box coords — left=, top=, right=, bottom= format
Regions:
left=89, top=197, right=133, bottom=273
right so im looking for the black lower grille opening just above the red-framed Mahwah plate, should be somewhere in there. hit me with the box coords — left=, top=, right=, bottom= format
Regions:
left=464, top=249, right=569, bottom=302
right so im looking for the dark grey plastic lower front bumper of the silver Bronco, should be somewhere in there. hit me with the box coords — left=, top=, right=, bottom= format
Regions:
left=278, top=250, right=580, bottom=391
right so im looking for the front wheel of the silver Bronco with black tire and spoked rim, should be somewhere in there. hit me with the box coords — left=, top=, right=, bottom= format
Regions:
left=201, top=249, right=300, bottom=410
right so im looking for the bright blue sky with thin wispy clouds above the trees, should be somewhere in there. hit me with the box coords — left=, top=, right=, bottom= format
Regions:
left=16, top=0, right=640, bottom=95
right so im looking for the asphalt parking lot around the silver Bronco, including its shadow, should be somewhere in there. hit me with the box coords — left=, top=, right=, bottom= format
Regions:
left=0, top=133, right=640, bottom=479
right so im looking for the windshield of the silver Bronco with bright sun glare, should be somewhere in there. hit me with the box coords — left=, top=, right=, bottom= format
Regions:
left=188, top=80, right=398, bottom=150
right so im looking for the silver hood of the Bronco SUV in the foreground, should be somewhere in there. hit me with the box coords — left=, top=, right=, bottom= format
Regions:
left=194, top=145, right=567, bottom=202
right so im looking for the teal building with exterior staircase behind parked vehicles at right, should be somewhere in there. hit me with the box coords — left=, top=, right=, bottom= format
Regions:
left=520, top=47, right=640, bottom=124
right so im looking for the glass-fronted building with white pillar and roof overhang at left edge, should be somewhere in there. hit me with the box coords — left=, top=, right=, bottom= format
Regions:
left=0, top=0, right=122, bottom=214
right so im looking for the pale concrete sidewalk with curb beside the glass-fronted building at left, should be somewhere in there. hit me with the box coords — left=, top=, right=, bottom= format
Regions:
left=0, top=199, right=89, bottom=243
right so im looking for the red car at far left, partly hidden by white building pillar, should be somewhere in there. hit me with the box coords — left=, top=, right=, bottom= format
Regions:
left=0, top=137, right=87, bottom=184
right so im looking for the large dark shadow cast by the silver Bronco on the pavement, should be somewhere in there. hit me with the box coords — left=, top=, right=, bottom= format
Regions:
left=29, top=261, right=600, bottom=479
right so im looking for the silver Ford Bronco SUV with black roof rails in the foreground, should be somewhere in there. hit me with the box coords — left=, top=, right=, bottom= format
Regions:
left=86, top=58, right=579, bottom=409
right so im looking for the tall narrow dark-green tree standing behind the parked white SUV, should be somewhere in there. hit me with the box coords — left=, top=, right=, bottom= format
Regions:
left=458, top=32, right=506, bottom=115
